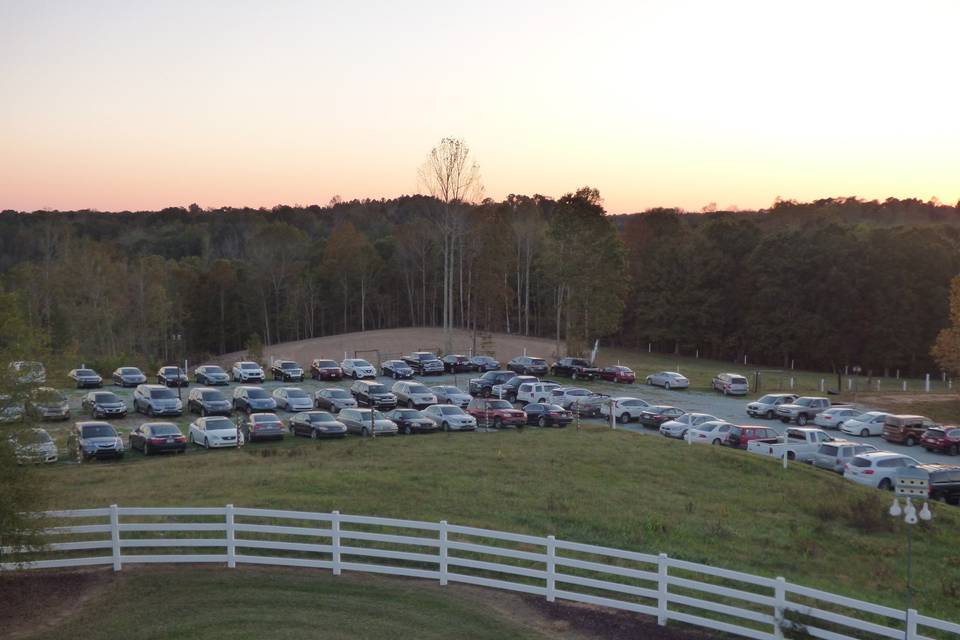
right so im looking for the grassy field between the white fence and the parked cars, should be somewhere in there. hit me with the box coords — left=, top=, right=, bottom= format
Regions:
left=31, top=426, right=960, bottom=620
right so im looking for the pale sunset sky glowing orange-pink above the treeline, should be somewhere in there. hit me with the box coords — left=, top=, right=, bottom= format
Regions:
left=0, top=0, right=960, bottom=213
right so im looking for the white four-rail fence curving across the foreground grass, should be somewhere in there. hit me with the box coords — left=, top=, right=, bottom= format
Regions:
left=0, top=505, right=960, bottom=640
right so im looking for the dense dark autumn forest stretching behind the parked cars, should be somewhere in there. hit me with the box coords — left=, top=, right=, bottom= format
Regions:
left=0, top=194, right=960, bottom=374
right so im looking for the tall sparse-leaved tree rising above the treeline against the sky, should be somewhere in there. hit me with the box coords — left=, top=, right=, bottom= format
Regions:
left=418, top=138, right=483, bottom=352
